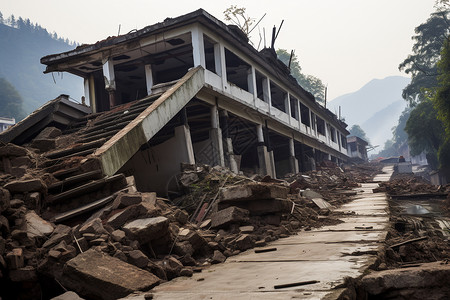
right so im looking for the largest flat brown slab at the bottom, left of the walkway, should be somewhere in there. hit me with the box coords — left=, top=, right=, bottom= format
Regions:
left=61, top=249, right=160, bottom=300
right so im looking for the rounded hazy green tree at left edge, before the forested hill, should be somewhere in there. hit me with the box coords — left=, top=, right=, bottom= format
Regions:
left=0, top=78, right=25, bottom=121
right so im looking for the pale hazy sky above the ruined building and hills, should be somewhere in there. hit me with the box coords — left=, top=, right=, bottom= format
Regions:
left=0, top=0, right=435, bottom=99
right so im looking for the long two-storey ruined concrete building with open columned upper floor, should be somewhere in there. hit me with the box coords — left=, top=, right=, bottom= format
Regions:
left=0, top=9, right=349, bottom=195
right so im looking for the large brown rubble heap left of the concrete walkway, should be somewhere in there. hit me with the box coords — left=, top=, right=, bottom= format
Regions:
left=0, top=142, right=362, bottom=299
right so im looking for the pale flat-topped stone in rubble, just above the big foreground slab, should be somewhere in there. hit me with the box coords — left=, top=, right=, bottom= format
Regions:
left=123, top=216, right=169, bottom=244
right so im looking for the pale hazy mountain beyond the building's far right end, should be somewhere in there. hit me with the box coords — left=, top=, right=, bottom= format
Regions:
left=328, top=76, right=410, bottom=148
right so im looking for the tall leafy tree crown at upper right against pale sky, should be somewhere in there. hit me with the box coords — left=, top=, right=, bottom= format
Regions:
left=399, top=9, right=450, bottom=106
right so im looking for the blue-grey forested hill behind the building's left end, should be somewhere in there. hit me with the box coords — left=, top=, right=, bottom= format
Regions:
left=0, top=19, right=83, bottom=119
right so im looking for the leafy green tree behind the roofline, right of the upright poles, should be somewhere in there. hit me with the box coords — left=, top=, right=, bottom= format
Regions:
left=277, top=49, right=325, bottom=104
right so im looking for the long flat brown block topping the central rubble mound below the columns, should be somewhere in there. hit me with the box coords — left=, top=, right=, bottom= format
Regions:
left=220, top=183, right=289, bottom=201
